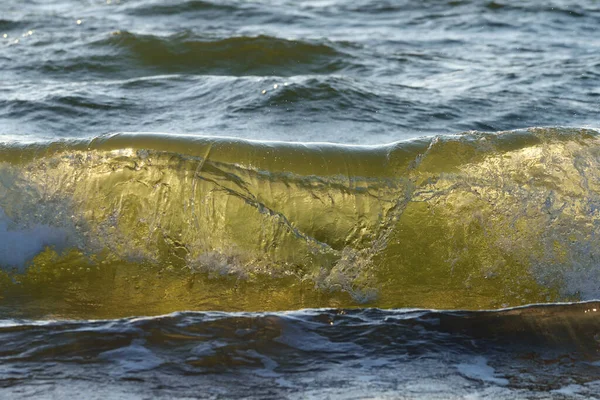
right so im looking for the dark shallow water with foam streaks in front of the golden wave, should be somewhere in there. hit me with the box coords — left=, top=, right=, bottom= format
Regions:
left=0, top=302, right=600, bottom=399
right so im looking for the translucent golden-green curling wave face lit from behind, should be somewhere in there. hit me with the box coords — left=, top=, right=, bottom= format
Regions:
left=0, top=129, right=600, bottom=311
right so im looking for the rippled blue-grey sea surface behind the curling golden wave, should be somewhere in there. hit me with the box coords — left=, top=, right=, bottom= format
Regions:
left=0, top=0, right=600, bottom=144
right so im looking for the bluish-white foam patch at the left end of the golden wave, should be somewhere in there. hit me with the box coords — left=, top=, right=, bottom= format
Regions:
left=0, top=207, right=68, bottom=272
